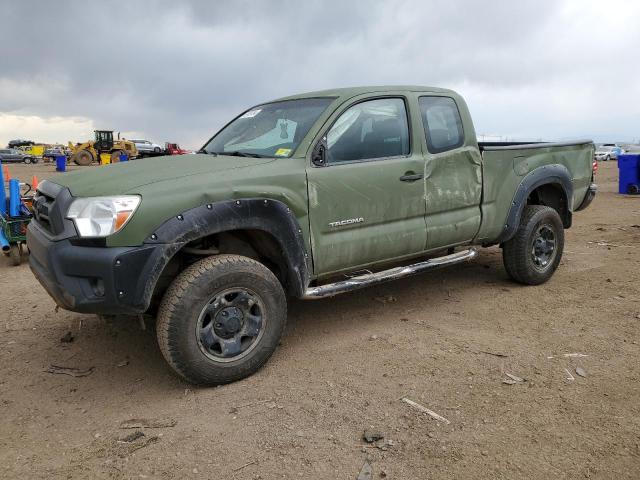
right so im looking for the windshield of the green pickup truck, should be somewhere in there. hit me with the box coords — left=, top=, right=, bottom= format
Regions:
left=202, top=97, right=334, bottom=157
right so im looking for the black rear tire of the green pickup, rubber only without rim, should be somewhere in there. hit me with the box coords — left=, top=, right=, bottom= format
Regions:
left=502, top=205, right=564, bottom=285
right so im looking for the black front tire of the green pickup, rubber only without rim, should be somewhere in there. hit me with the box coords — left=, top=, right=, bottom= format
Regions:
left=156, top=255, right=287, bottom=385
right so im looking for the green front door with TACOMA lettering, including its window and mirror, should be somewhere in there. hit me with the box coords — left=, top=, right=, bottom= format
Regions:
left=307, top=95, right=426, bottom=275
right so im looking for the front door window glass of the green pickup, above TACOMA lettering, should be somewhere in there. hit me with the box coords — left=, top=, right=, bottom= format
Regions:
left=327, top=98, right=409, bottom=164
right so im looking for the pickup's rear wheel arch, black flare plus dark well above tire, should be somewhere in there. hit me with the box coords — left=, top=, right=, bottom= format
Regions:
left=498, top=164, right=573, bottom=243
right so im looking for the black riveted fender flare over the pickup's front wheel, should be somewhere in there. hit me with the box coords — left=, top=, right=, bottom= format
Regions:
left=144, top=198, right=310, bottom=297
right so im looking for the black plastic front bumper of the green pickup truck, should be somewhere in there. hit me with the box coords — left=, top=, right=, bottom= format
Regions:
left=27, top=221, right=170, bottom=314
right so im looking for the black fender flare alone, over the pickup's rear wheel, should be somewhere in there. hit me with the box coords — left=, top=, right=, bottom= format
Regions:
left=497, top=164, right=573, bottom=243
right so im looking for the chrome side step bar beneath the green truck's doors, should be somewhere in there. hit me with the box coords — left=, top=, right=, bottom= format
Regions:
left=302, top=248, right=478, bottom=300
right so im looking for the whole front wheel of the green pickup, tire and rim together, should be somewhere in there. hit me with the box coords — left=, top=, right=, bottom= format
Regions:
left=157, top=255, right=287, bottom=385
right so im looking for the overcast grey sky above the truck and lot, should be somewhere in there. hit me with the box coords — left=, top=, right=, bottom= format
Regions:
left=0, top=0, right=640, bottom=148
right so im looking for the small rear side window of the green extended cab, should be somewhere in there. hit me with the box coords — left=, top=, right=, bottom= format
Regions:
left=419, top=97, right=464, bottom=153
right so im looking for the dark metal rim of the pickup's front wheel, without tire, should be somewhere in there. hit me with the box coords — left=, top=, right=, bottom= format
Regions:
left=196, top=288, right=266, bottom=362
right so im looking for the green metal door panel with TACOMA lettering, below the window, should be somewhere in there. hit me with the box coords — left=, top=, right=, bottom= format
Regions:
left=307, top=155, right=426, bottom=275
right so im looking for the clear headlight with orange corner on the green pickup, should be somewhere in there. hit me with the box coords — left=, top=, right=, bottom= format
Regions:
left=67, top=195, right=140, bottom=237
